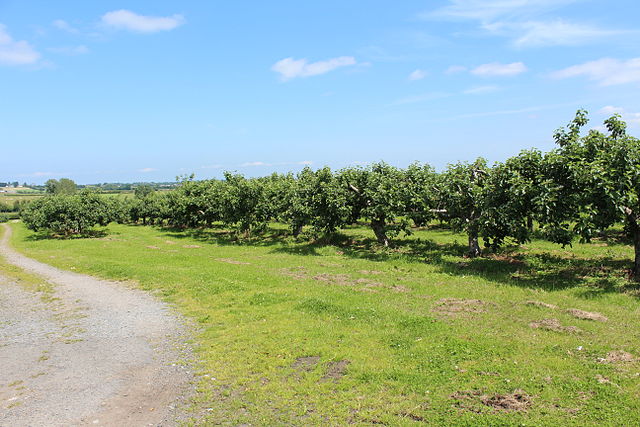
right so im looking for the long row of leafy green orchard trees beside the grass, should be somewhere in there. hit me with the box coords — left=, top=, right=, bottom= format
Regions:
left=23, top=110, right=640, bottom=278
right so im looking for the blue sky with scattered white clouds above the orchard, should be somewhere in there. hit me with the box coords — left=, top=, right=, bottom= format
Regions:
left=0, top=0, right=640, bottom=184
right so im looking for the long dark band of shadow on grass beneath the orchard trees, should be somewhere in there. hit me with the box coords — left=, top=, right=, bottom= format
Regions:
left=162, top=227, right=640, bottom=298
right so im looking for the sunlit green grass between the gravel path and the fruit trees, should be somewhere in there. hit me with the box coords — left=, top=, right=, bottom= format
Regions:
left=6, top=224, right=640, bottom=426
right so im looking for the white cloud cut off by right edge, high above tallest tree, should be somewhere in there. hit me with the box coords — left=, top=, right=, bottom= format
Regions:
left=551, top=58, right=640, bottom=86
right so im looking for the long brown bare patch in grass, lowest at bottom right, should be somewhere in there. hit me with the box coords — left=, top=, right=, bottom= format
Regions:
left=449, top=389, right=531, bottom=413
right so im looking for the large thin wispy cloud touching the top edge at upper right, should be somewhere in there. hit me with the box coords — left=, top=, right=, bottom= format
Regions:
left=420, top=0, right=630, bottom=48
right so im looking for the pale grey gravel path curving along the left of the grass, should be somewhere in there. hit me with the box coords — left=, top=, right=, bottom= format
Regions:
left=0, top=224, right=193, bottom=427
